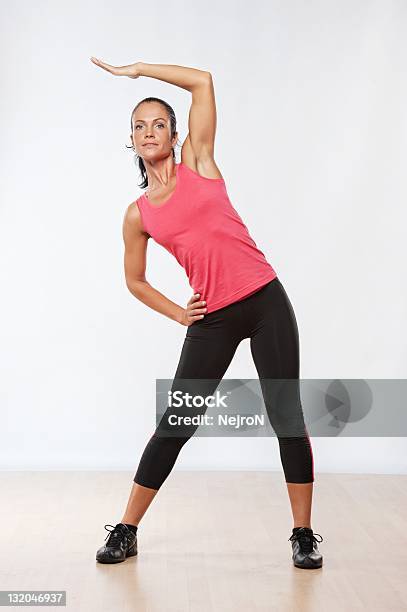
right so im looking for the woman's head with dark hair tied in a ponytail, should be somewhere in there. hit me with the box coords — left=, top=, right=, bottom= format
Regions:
left=130, top=97, right=178, bottom=189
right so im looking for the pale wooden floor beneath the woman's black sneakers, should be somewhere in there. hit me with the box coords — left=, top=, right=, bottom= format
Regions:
left=0, top=471, right=407, bottom=612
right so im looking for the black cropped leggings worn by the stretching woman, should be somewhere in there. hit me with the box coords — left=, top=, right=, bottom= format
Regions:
left=133, top=277, right=314, bottom=489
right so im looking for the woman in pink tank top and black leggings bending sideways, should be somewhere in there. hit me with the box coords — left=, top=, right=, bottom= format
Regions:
left=91, top=57, right=322, bottom=569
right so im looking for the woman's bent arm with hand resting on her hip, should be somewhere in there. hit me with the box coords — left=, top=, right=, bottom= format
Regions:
left=123, top=202, right=206, bottom=326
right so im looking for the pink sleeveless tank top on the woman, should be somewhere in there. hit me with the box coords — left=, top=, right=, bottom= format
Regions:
left=136, top=162, right=277, bottom=313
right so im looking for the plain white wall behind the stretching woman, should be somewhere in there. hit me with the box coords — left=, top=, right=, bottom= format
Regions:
left=0, top=0, right=407, bottom=473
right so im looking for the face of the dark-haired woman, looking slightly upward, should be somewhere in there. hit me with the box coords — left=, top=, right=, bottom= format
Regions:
left=131, top=102, right=177, bottom=161
